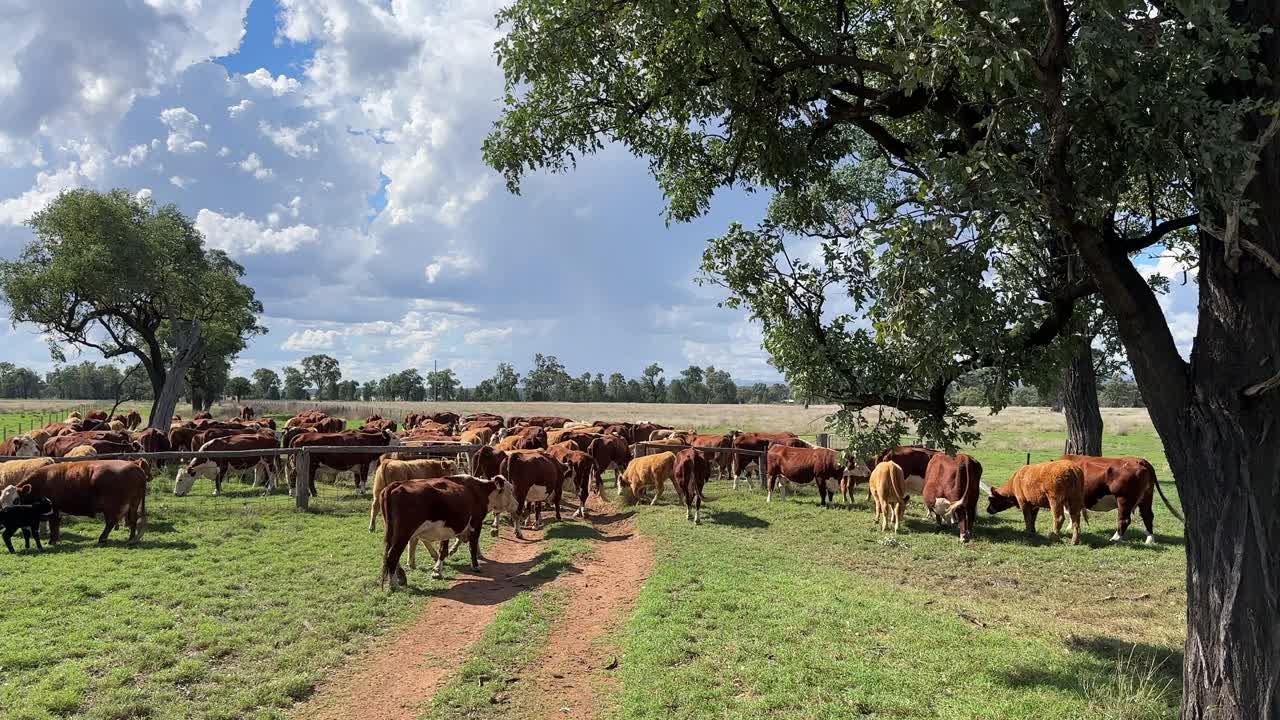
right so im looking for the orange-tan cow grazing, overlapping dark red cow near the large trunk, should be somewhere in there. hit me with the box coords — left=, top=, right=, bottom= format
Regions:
left=987, top=460, right=1084, bottom=544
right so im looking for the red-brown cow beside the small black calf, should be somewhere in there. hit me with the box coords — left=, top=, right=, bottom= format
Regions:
left=27, top=460, right=151, bottom=544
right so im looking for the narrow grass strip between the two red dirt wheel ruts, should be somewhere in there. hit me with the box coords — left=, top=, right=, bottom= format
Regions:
left=421, top=523, right=599, bottom=720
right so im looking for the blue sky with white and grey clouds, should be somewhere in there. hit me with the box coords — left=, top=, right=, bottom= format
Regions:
left=0, top=0, right=1194, bottom=384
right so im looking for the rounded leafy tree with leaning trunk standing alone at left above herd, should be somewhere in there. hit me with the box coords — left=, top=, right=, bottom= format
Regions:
left=0, top=190, right=265, bottom=423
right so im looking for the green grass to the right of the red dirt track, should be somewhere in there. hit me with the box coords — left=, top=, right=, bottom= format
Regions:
left=613, top=425, right=1185, bottom=720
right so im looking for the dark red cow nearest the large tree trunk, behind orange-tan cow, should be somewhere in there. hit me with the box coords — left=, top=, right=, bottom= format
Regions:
left=1062, top=455, right=1183, bottom=544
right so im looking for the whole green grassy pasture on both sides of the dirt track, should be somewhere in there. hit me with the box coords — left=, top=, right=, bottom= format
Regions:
left=0, top=406, right=1185, bottom=720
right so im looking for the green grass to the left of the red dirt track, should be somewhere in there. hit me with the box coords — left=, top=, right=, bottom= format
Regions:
left=0, top=466, right=573, bottom=720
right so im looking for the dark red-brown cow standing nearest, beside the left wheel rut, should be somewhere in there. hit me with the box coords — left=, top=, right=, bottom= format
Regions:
left=379, top=475, right=518, bottom=591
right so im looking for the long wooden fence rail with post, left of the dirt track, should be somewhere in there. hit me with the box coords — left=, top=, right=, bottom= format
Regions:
left=0, top=443, right=483, bottom=510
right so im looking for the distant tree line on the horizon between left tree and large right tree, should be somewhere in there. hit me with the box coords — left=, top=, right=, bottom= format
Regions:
left=223, top=352, right=791, bottom=404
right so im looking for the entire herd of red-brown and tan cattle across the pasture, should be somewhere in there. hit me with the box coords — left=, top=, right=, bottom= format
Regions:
left=0, top=407, right=1180, bottom=589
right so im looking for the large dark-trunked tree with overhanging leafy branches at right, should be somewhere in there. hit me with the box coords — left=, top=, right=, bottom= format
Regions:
left=484, top=0, right=1280, bottom=719
